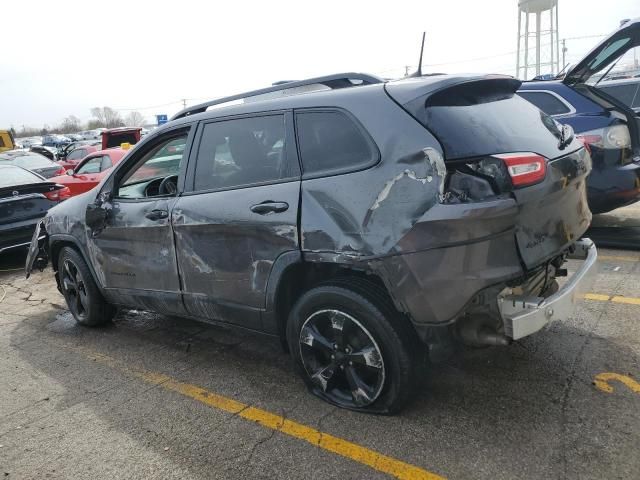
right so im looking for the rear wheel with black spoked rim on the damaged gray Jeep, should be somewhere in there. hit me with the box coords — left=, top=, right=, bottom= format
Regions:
left=287, top=277, right=426, bottom=414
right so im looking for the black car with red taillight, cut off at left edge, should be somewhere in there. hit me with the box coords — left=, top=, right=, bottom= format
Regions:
left=0, top=164, right=69, bottom=253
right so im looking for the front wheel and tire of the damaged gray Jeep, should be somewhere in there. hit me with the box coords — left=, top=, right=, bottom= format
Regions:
left=58, top=247, right=115, bottom=327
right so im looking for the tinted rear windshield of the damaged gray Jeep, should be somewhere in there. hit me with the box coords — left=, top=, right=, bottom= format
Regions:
left=415, top=93, right=568, bottom=160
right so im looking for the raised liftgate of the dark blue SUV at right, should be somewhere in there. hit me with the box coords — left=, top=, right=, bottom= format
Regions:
left=562, top=18, right=640, bottom=85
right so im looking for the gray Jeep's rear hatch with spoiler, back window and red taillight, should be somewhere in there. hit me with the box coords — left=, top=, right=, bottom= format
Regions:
left=386, top=76, right=591, bottom=269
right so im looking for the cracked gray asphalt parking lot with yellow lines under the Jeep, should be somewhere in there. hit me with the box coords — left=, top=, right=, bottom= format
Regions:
left=0, top=209, right=640, bottom=479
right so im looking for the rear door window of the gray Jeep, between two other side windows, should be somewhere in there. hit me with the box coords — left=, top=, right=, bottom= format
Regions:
left=194, top=115, right=292, bottom=190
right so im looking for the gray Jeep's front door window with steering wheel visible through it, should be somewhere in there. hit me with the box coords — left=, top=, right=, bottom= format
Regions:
left=117, top=133, right=187, bottom=198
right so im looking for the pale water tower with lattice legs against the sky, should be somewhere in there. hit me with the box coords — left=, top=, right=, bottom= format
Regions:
left=516, top=0, right=560, bottom=80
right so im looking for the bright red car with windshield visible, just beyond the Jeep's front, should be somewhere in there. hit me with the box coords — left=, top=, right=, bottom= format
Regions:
left=50, top=148, right=129, bottom=197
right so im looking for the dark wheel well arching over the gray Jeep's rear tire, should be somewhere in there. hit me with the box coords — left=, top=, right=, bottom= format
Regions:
left=274, top=262, right=402, bottom=350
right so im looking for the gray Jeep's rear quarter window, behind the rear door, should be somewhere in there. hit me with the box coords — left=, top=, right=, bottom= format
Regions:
left=296, top=111, right=377, bottom=175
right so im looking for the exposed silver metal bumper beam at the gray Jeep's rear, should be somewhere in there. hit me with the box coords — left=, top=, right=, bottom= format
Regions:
left=498, top=238, right=598, bottom=340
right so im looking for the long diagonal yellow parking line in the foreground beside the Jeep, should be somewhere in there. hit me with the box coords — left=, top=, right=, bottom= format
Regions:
left=69, top=345, right=444, bottom=480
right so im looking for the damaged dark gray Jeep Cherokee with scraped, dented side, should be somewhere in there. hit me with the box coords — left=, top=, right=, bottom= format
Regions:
left=26, top=73, right=596, bottom=413
